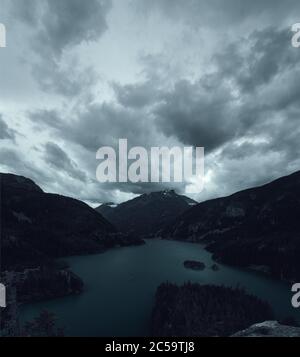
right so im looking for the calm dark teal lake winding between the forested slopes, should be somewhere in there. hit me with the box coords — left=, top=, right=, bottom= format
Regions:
left=20, top=240, right=300, bottom=337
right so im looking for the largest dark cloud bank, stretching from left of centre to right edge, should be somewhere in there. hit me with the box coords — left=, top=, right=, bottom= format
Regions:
left=27, top=22, right=300, bottom=200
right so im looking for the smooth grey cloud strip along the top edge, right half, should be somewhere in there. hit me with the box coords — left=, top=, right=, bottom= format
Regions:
left=135, top=0, right=300, bottom=28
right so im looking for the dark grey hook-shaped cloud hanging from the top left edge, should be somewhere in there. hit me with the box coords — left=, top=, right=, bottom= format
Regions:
left=13, top=0, right=111, bottom=97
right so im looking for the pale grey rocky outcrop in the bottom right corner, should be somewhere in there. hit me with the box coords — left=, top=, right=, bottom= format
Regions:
left=232, top=321, right=300, bottom=337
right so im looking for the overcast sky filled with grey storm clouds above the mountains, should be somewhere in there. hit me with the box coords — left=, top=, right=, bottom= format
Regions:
left=0, top=0, right=300, bottom=205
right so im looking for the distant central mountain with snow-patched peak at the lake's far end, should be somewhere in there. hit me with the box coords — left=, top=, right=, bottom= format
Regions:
left=96, top=190, right=196, bottom=237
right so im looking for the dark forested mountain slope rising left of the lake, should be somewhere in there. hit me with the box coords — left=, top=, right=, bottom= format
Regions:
left=0, top=174, right=139, bottom=270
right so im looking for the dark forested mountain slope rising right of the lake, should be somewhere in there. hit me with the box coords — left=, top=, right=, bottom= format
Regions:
left=163, top=172, right=300, bottom=280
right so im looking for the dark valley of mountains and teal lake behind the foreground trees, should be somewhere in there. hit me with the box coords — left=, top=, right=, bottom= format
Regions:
left=1, top=172, right=300, bottom=336
